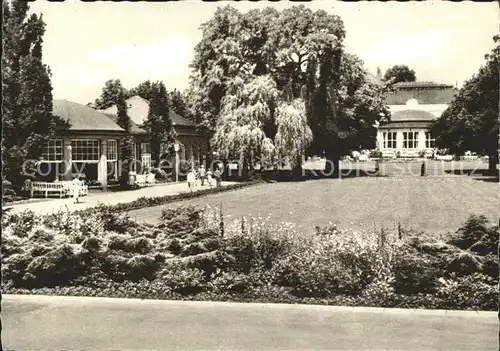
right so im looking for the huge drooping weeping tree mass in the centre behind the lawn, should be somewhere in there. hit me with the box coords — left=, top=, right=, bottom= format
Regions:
left=190, top=6, right=387, bottom=179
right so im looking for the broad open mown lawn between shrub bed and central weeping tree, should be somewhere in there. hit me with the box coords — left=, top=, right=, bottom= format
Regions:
left=129, top=163, right=500, bottom=233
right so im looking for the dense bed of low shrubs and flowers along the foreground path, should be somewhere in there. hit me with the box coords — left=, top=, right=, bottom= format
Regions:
left=2, top=206, right=498, bottom=310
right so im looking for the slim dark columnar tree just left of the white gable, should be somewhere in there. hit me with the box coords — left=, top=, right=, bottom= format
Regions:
left=115, top=90, right=134, bottom=188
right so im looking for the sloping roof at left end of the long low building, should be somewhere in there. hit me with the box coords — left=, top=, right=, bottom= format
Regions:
left=52, top=100, right=124, bottom=132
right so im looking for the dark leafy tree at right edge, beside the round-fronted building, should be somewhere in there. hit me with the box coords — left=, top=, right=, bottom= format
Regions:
left=431, top=36, right=500, bottom=173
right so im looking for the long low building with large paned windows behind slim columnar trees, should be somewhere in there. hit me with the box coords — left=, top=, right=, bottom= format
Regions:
left=36, top=97, right=208, bottom=188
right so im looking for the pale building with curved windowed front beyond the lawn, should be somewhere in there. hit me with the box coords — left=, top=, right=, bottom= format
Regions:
left=377, top=82, right=457, bottom=157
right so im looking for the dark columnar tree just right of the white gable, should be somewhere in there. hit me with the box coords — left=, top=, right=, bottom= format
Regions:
left=144, top=82, right=175, bottom=165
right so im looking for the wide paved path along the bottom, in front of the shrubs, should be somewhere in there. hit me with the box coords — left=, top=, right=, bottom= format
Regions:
left=2, top=295, right=498, bottom=350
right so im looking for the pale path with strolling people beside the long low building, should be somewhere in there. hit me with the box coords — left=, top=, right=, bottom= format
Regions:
left=5, top=182, right=235, bottom=214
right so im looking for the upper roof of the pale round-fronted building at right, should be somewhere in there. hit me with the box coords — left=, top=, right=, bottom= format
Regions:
left=386, top=82, right=457, bottom=105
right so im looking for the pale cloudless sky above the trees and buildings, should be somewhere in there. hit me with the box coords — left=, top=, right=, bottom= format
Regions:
left=30, top=0, right=500, bottom=104
